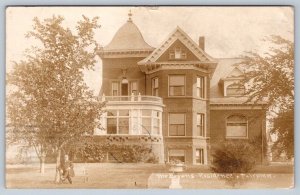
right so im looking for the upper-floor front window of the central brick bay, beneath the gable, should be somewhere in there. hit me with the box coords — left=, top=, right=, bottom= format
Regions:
left=169, top=75, right=185, bottom=96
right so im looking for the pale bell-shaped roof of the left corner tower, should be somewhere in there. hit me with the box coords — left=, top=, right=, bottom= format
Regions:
left=103, top=20, right=154, bottom=52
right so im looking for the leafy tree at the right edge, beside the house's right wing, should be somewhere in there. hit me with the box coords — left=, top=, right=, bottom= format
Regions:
left=240, top=35, right=294, bottom=158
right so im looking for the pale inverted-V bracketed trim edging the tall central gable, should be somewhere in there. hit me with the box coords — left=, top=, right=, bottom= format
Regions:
left=138, top=26, right=216, bottom=65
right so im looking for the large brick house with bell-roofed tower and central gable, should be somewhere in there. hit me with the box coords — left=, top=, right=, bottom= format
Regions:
left=94, top=13, right=266, bottom=165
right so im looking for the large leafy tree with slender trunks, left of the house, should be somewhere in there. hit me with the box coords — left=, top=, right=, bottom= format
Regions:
left=7, top=16, right=103, bottom=182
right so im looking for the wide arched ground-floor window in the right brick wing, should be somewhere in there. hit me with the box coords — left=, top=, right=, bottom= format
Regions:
left=226, top=115, right=248, bottom=138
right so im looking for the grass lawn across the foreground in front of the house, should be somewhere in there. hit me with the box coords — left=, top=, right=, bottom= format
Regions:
left=6, top=163, right=293, bottom=189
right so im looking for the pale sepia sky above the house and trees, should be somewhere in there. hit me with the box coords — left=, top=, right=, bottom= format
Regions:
left=6, top=6, right=294, bottom=95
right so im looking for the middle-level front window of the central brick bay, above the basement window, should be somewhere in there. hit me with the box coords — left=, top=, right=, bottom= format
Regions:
left=169, top=113, right=185, bottom=136
